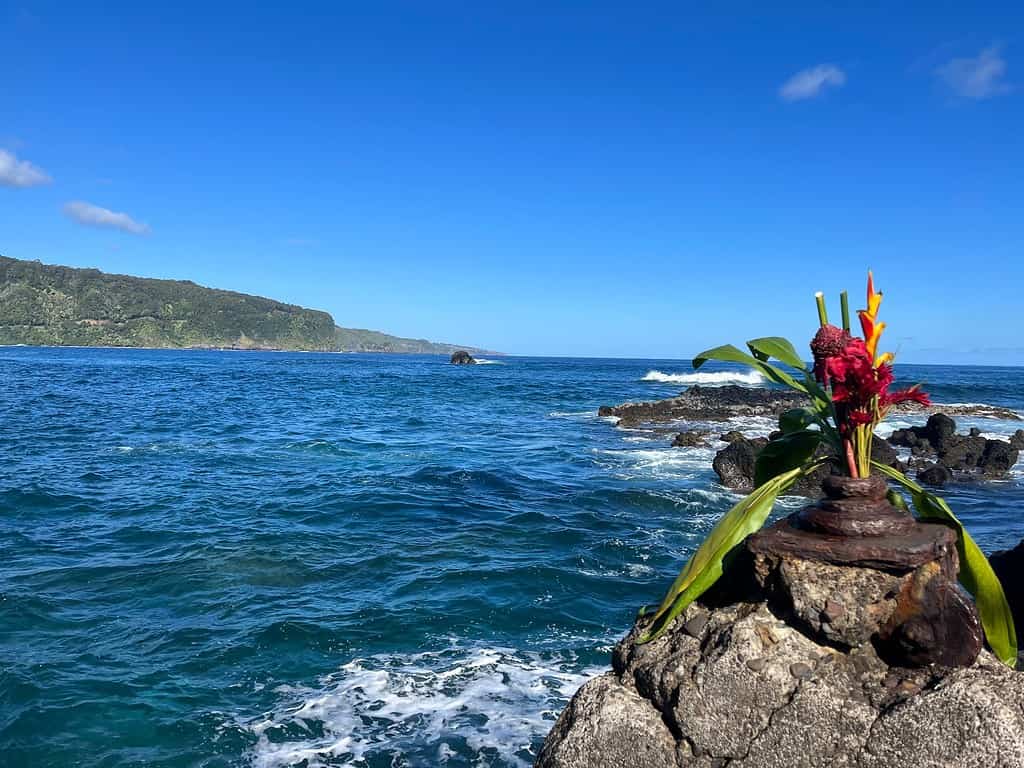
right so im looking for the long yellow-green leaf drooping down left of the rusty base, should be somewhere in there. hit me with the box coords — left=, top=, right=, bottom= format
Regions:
left=639, top=462, right=820, bottom=643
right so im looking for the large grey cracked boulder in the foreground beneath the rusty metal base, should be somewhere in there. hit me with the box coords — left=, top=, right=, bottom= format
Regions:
left=537, top=600, right=1024, bottom=768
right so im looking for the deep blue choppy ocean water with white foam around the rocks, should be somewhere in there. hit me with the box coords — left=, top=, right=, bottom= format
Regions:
left=0, top=348, right=1024, bottom=768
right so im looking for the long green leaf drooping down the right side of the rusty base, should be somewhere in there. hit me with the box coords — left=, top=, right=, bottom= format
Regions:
left=871, top=461, right=1017, bottom=667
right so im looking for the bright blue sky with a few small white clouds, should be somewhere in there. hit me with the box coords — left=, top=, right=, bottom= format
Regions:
left=0, top=2, right=1024, bottom=365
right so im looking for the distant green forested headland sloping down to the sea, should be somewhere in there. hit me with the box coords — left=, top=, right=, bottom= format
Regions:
left=0, top=256, right=494, bottom=354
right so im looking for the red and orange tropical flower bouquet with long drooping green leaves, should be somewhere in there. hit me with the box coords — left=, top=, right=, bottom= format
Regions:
left=640, top=272, right=1017, bottom=666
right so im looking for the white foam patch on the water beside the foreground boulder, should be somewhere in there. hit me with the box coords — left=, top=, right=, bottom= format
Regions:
left=244, top=648, right=602, bottom=768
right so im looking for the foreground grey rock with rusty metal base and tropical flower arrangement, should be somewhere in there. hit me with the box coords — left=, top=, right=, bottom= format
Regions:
left=537, top=273, right=1024, bottom=768
